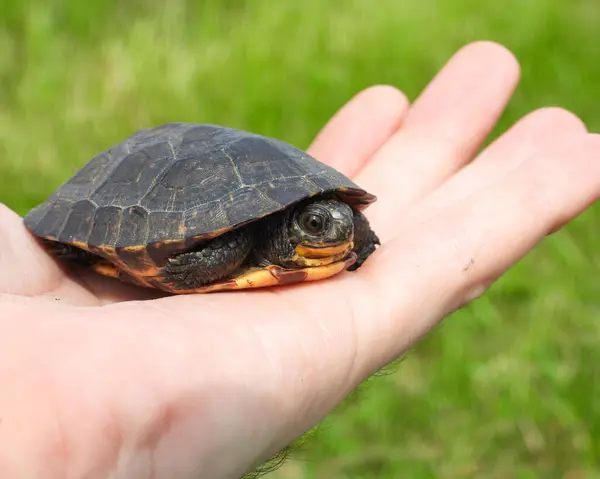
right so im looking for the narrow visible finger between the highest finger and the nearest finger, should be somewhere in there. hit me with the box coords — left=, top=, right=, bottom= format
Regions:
left=412, top=108, right=587, bottom=224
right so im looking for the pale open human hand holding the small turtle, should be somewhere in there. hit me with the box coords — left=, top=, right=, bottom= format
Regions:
left=0, top=43, right=600, bottom=479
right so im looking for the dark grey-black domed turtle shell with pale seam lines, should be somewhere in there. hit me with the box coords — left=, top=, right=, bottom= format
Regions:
left=24, top=123, right=375, bottom=282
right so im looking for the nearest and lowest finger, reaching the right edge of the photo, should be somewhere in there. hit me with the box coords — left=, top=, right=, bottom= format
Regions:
left=354, top=135, right=600, bottom=374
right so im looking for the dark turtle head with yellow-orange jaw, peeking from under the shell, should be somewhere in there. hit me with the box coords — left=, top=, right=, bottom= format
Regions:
left=288, top=199, right=354, bottom=266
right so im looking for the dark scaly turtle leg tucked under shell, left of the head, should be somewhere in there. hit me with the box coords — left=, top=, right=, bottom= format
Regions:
left=156, top=228, right=253, bottom=293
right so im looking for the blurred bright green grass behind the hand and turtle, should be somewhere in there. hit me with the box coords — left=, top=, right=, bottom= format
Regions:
left=0, top=0, right=600, bottom=479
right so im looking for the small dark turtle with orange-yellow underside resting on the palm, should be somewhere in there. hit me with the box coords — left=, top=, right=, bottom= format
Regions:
left=24, top=122, right=380, bottom=294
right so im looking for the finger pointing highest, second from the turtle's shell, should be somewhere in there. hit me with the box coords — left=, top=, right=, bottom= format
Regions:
left=357, top=42, right=519, bottom=236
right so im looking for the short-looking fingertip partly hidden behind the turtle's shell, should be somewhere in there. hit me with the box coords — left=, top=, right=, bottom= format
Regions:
left=308, top=85, right=408, bottom=177
